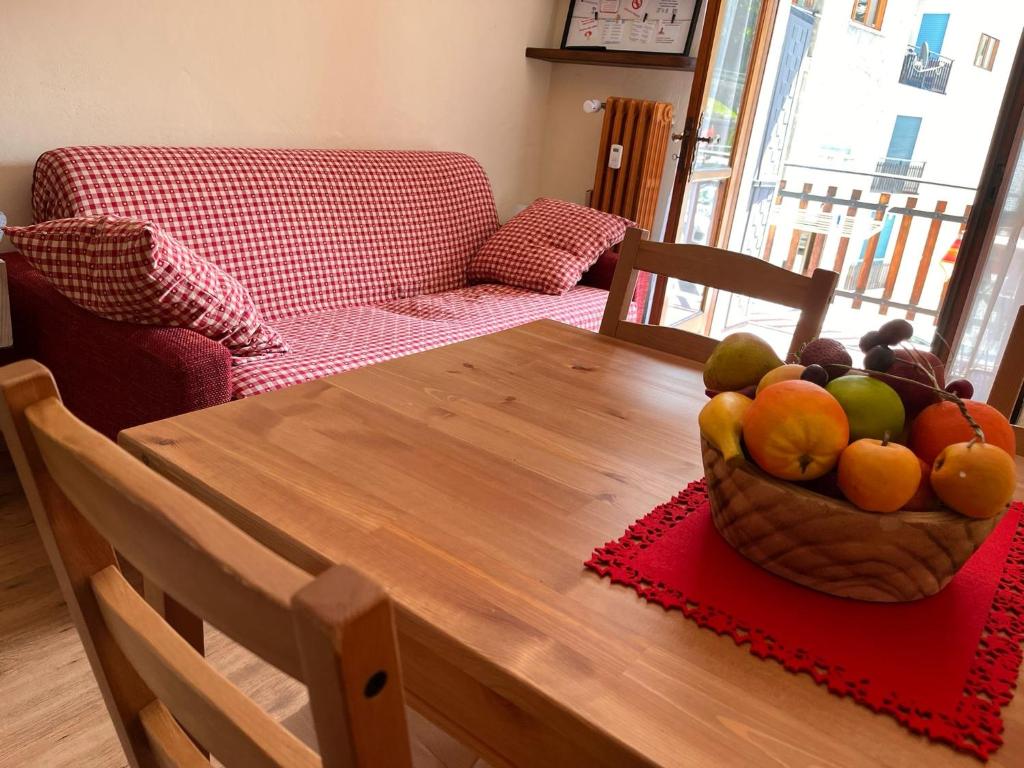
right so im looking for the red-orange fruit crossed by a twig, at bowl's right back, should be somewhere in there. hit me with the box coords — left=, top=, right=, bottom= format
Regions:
left=910, top=400, right=1017, bottom=464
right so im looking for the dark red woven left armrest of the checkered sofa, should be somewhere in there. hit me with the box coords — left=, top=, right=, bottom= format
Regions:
left=3, top=253, right=231, bottom=438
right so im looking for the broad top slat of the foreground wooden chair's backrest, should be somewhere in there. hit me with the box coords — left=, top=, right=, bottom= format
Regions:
left=26, top=397, right=312, bottom=680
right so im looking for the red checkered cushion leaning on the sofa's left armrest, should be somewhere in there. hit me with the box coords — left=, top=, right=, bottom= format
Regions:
left=4, top=216, right=287, bottom=356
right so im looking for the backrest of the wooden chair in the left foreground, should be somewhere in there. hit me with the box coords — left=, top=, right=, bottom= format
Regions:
left=0, top=360, right=411, bottom=768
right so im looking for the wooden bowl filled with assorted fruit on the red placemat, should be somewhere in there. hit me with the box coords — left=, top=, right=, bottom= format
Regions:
left=700, top=322, right=1017, bottom=601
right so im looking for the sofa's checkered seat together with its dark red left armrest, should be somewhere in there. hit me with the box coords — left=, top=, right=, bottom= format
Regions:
left=0, top=253, right=618, bottom=438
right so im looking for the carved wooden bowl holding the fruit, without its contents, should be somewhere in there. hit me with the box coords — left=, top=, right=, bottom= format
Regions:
left=700, top=437, right=1002, bottom=602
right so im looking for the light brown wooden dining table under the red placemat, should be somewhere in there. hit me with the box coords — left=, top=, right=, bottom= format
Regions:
left=120, top=321, right=1024, bottom=767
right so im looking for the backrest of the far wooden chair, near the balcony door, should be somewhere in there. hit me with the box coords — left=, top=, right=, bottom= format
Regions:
left=601, top=228, right=839, bottom=362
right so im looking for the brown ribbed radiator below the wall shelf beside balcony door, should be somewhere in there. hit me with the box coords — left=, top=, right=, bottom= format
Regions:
left=590, top=96, right=673, bottom=313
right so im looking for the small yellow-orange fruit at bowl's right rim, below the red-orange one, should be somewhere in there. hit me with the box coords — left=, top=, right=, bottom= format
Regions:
left=932, top=442, right=1017, bottom=517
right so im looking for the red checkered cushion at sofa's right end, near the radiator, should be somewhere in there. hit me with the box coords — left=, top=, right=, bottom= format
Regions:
left=467, top=198, right=632, bottom=295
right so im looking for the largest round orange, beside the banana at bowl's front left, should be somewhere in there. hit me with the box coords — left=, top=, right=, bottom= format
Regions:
left=743, top=380, right=850, bottom=480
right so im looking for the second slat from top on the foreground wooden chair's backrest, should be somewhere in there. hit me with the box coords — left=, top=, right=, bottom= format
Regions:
left=92, top=566, right=319, bottom=768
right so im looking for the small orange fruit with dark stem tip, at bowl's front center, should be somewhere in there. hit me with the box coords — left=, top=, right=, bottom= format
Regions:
left=839, top=437, right=921, bottom=512
